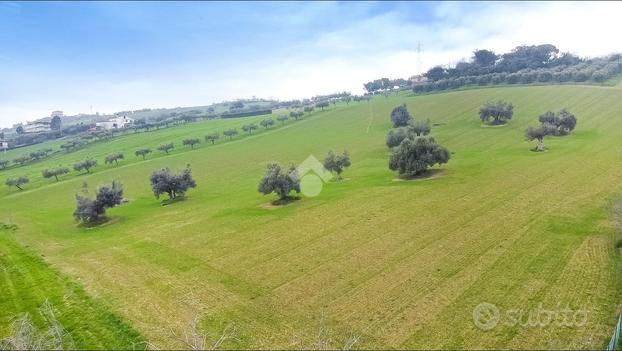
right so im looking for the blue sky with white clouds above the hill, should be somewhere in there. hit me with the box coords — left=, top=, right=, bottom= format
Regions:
left=0, top=1, right=622, bottom=127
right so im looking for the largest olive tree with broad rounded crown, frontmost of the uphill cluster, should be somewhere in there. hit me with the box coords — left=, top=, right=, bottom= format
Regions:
left=389, top=136, right=450, bottom=177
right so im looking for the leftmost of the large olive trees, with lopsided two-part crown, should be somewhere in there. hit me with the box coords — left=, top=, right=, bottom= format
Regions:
left=73, top=182, right=123, bottom=224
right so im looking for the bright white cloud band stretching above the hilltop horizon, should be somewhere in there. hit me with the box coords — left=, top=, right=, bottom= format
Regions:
left=0, top=2, right=622, bottom=126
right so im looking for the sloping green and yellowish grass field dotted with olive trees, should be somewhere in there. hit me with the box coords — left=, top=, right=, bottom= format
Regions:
left=0, top=86, right=622, bottom=349
